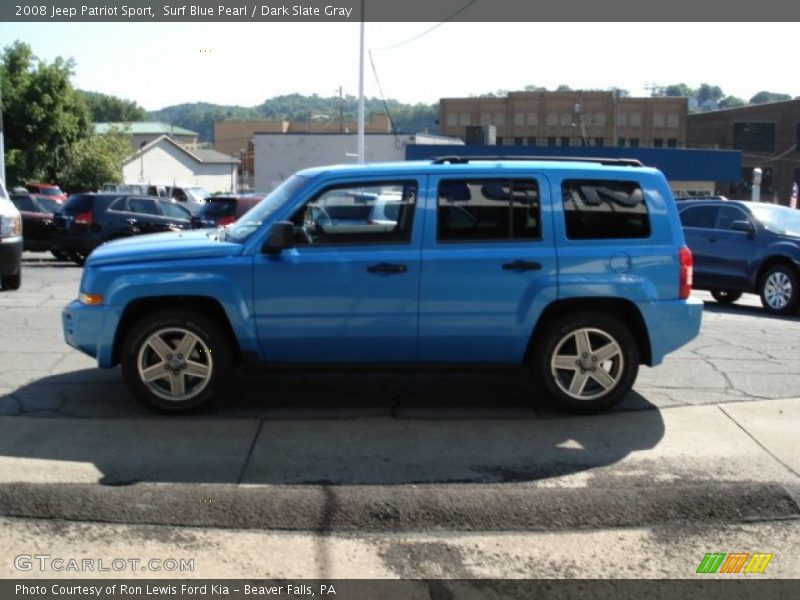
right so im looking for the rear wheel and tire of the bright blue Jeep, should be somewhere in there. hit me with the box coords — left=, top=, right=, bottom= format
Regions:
left=531, top=311, right=639, bottom=414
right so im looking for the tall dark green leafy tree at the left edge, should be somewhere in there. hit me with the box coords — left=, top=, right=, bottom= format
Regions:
left=0, top=41, right=90, bottom=186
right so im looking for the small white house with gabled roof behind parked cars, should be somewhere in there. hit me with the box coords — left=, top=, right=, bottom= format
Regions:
left=122, top=135, right=239, bottom=193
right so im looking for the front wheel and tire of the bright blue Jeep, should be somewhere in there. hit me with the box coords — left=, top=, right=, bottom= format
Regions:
left=121, top=309, right=232, bottom=414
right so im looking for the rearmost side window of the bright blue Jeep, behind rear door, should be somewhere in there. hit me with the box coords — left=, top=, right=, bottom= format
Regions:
left=561, top=179, right=650, bottom=240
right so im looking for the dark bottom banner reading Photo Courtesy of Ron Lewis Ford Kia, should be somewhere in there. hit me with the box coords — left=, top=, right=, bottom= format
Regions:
left=0, top=575, right=800, bottom=600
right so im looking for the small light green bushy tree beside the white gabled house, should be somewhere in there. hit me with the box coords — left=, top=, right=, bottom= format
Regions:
left=59, top=129, right=131, bottom=192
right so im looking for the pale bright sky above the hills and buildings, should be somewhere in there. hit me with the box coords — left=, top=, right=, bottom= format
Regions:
left=0, top=22, right=800, bottom=110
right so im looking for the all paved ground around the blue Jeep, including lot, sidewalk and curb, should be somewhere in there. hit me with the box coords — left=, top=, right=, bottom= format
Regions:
left=0, top=253, right=800, bottom=578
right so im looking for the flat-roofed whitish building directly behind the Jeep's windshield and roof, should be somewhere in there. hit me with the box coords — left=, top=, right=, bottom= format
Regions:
left=253, top=133, right=464, bottom=192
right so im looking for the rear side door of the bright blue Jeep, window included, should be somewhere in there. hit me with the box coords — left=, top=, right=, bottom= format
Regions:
left=419, top=170, right=557, bottom=364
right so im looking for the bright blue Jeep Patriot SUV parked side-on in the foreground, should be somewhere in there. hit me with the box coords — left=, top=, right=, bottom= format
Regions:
left=63, top=157, right=702, bottom=413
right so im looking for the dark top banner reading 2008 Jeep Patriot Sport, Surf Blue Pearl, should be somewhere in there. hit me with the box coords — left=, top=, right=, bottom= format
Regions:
left=0, top=0, right=800, bottom=22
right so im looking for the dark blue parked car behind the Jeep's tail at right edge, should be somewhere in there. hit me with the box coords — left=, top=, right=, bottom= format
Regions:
left=680, top=200, right=800, bottom=314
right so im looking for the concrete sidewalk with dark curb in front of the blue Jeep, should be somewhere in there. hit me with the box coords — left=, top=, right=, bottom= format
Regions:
left=0, top=399, right=800, bottom=578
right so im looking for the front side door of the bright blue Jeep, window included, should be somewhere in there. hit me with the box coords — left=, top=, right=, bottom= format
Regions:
left=253, top=177, right=422, bottom=363
